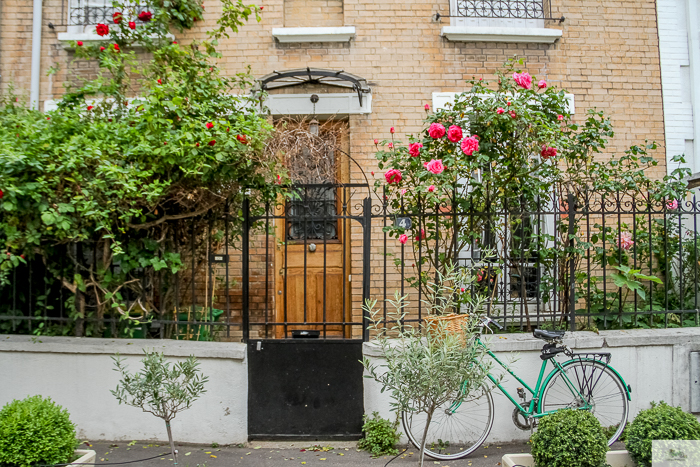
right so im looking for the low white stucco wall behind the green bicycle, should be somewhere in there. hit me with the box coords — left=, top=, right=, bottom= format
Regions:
left=363, top=328, right=700, bottom=442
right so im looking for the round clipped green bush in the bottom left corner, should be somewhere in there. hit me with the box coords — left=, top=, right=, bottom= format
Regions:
left=0, top=396, right=78, bottom=467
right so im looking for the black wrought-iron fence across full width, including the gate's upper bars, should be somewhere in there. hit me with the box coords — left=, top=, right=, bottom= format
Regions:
left=0, top=188, right=700, bottom=341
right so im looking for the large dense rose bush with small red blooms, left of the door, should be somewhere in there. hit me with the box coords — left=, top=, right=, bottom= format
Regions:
left=0, top=0, right=284, bottom=335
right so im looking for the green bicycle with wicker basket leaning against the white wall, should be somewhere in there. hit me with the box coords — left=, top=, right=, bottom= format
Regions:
left=401, top=317, right=632, bottom=460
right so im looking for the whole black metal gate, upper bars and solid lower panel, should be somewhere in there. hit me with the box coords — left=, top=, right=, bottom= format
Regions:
left=241, top=184, right=371, bottom=440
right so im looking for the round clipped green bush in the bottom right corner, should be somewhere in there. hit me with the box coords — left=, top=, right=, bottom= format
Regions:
left=625, top=402, right=700, bottom=467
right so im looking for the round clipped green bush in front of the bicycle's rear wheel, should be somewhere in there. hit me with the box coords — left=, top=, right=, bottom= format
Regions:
left=530, top=409, right=608, bottom=467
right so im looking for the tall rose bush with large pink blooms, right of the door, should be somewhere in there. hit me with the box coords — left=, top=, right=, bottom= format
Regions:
left=375, top=60, right=687, bottom=326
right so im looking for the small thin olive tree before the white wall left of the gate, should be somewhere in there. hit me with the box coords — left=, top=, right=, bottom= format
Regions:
left=111, top=350, right=209, bottom=464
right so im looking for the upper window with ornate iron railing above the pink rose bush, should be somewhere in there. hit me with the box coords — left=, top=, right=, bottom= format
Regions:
left=450, top=0, right=552, bottom=28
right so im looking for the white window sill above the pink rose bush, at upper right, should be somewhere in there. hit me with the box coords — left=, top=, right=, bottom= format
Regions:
left=441, top=26, right=562, bottom=44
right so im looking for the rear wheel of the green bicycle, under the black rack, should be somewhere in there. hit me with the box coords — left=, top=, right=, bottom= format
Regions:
left=540, top=360, right=629, bottom=446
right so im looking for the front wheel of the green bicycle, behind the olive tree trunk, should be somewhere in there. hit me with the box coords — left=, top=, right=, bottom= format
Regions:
left=401, top=386, right=494, bottom=460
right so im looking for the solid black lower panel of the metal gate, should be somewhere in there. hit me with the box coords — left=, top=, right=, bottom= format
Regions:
left=248, top=339, right=364, bottom=440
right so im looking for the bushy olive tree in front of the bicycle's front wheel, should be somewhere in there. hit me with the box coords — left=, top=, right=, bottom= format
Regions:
left=362, top=266, right=490, bottom=466
